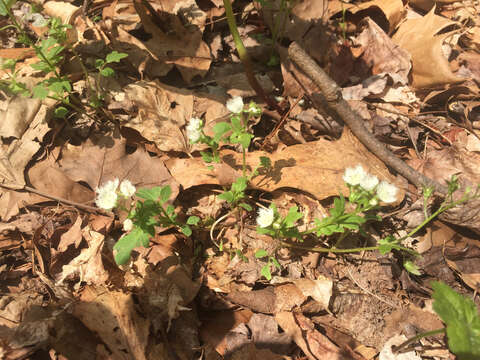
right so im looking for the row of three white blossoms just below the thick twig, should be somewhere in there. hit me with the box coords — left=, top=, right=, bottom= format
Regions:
left=343, top=165, right=398, bottom=203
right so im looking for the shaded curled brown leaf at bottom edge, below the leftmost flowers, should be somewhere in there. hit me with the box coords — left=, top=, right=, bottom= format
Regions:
left=72, top=286, right=150, bottom=360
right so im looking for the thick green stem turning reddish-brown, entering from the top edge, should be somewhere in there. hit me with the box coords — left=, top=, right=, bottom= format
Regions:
left=223, top=0, right=282, bottom=112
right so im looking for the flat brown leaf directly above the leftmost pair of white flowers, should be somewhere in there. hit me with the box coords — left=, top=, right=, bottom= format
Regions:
left=57, top=135, right=178, bottom=196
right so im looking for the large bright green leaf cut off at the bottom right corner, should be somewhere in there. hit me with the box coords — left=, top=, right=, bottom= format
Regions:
left=432, top=282, right=480, bottom=360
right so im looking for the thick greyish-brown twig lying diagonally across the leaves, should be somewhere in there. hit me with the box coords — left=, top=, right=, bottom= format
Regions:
left=288, top=42, right=448, bottom=194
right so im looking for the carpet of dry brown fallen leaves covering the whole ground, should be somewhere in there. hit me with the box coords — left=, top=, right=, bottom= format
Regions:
left=0, top=0, right=480, bottom=360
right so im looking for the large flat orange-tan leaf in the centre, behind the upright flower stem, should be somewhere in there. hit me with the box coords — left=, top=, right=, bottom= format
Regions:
left=166, top=130, right=404, bottom=201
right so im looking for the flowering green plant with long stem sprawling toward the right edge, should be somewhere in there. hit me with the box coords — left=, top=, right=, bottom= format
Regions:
left=253, top=165, right=480, bottom=275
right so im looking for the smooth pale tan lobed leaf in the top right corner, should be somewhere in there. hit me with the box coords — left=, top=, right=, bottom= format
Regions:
left=393, top=8, right=463, bottom=88
